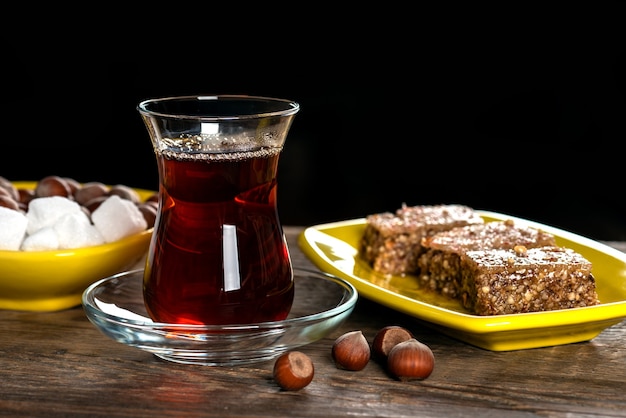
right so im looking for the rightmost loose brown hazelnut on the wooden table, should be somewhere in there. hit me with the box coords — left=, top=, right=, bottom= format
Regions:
left=387, top=338, right=435, bottom=381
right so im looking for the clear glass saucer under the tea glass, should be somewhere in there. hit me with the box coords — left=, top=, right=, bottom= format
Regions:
left=82, top=269, right=358, bottom=366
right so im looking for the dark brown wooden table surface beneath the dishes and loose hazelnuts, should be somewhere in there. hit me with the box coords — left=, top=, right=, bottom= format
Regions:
left=0, top=227, right=626, bottom=418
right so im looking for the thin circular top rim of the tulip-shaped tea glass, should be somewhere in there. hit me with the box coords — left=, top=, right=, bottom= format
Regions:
left=137, top=94, right=300, bottom=122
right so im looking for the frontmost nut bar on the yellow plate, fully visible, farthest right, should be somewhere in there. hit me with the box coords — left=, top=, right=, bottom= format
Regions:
left=461, top=246, right=599, bottom=315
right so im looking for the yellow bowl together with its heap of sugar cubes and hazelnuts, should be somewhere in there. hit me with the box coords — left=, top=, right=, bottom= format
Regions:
left=0, top=176, right=157, bottom=312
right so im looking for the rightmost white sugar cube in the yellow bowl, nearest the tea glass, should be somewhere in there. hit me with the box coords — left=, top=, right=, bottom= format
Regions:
left=91, top=195, right=148, bottom=242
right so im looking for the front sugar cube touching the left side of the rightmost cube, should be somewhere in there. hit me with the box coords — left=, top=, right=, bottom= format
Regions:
left=53, top=211, right=104, bottom=249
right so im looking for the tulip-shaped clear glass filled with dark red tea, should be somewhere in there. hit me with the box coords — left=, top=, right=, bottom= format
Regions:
left=137, top=96, right=299, bottom=325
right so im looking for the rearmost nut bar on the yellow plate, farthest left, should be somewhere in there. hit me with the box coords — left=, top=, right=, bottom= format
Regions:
left=360, top=204, right=484, bottom=275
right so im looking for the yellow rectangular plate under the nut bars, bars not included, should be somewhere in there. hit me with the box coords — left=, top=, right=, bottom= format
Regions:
left=298, top=211, right=626, bottom=351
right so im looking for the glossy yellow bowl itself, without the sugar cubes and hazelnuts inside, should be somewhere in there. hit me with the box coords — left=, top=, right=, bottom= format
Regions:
left=0, top=182, right=155, bottom=311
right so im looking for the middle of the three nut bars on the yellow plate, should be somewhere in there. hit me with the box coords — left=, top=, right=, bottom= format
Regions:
left=418, top=219, right=556, bottom=298
